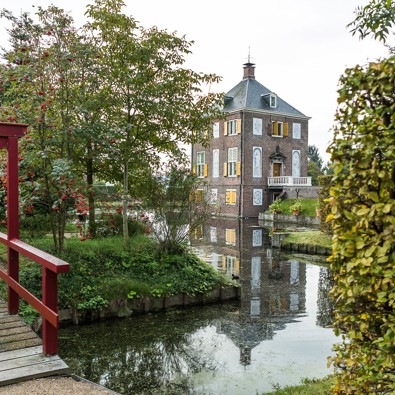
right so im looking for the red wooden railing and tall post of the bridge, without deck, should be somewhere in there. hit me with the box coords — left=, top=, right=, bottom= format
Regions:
left=0, top=122, right=70, bottom=355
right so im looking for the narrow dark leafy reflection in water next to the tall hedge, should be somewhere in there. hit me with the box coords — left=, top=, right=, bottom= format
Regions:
left=317, top=267, right=334, bottom=327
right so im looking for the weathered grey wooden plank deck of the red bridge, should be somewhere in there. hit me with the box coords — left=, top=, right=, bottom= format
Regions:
left=0, top=301, right=68, bottom=386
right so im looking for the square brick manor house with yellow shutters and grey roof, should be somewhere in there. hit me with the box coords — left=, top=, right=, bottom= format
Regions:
left=191, top=62, right=311, bottom=218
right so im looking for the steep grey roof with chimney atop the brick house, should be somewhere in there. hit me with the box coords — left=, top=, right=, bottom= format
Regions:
left=223, top=63, right=309, bottom=118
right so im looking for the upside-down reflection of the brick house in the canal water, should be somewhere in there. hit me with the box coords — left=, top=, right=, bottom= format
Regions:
left=191, top=218, right=306, bottom=365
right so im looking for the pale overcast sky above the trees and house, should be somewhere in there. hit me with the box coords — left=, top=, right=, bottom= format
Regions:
left=0, top=0, right=387, bottom=160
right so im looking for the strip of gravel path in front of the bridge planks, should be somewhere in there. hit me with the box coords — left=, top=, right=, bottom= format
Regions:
left=0, top=376, right=117, bottom=395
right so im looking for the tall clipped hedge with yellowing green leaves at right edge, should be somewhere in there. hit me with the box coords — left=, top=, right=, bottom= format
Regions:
left=330, top=56, right=395, bottom=394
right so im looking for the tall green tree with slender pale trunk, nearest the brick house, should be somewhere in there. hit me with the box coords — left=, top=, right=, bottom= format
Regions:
left=87, top=0, right=221, bottom=246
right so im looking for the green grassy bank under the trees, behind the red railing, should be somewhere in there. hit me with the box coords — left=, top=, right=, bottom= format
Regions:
left=0, top=235, right=235, bottom=318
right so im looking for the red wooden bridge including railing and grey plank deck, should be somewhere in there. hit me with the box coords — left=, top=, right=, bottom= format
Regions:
left=0, top=122, right=69, bottom=385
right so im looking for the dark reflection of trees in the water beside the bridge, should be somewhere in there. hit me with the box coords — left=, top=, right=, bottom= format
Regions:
left=60, top=304, right=237, bottom=394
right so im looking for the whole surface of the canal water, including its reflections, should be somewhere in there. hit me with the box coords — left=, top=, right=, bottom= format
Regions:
left=59, top=219, right=338, bottom=395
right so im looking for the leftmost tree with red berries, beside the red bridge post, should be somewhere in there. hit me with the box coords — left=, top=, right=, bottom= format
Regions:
left=1, top=6, right=85, bottom=250
